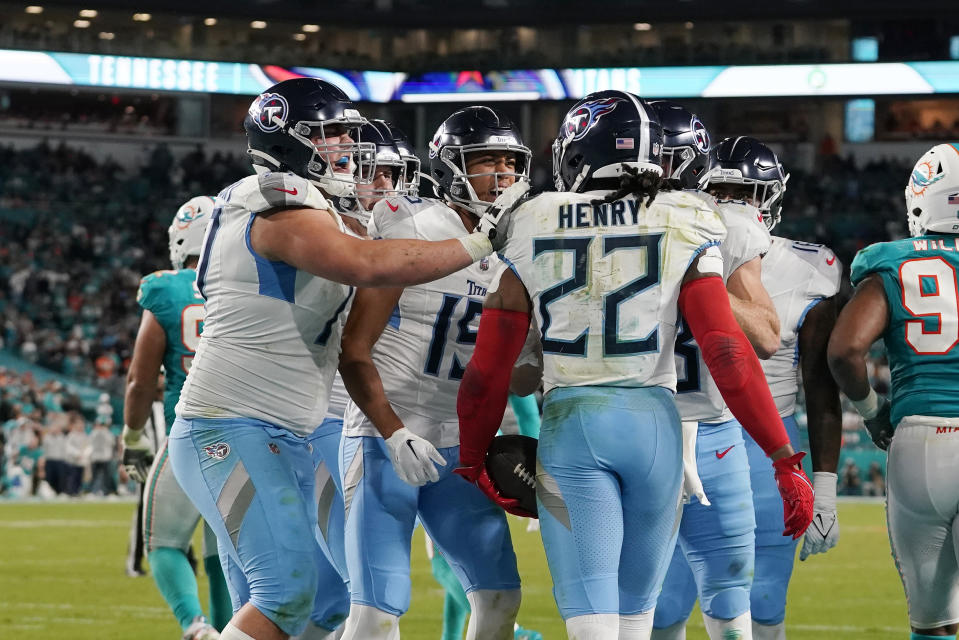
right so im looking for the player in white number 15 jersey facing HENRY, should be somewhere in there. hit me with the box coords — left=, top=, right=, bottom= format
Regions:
left=340, top=107, right=531, bottom=640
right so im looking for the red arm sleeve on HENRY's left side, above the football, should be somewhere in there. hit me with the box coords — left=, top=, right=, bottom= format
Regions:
left=456, top=309, right=529, bottom=467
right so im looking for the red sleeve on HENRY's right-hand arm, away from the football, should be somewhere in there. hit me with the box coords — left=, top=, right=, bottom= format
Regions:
left=679, top=276, right=789, bottom=455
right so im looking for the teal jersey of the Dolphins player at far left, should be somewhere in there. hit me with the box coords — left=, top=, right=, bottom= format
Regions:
left=137, top=269, right=203, bottom=433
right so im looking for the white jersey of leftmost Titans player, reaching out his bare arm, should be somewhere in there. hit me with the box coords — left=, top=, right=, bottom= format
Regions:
left=177, top=173, right=353, bottom=436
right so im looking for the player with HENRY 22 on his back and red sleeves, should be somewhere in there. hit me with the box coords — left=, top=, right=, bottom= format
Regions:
left=456, top=91, right=813, bottom=640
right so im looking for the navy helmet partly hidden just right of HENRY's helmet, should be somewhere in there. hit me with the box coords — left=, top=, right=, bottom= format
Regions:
left=649, top=100, right=710, bottom=191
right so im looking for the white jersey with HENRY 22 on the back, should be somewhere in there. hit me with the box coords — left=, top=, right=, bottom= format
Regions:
left=501, top=191, right=726, bottom=392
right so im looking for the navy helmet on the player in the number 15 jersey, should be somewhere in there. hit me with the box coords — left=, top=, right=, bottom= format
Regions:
left=430, top=107, right=533, bottom=216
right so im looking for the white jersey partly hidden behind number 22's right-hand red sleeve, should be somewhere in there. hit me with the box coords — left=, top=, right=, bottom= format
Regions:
left=676, top=195, right=772, bottom=422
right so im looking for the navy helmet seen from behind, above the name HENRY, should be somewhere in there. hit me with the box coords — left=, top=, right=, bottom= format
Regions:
left=553, top=90, right=663, bottom=191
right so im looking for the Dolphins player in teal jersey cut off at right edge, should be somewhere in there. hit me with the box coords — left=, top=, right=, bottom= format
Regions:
left=829, top=142, right=959, bottom=640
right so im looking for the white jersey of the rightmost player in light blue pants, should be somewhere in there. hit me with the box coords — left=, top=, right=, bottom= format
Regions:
left=761, top=236, right=842, bottom=417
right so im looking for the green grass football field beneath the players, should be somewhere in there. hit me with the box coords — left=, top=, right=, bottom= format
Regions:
left=0, top=502, right=909, bottom=640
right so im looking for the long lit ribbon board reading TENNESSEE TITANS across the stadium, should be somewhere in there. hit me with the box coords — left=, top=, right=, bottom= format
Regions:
left=0, top=49, right=959, bottom=103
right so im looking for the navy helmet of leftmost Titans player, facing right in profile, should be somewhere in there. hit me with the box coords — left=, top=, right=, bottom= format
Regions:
left=243, top=78, right=375, bottom=196
